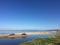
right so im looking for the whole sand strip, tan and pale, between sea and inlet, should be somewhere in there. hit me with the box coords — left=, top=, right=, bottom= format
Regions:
left=0, top=32, right=51, bottom=38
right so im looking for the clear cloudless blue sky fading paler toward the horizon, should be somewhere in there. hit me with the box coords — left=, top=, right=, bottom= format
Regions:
left=0, top=0, right=60, bottom=30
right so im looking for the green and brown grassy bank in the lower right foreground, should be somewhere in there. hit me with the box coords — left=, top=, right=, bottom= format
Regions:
left=20, top=36, right=60, bottom=45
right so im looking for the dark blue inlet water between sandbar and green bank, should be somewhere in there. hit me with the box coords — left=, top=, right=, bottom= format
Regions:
left=0, top=35, right=52, bottom=45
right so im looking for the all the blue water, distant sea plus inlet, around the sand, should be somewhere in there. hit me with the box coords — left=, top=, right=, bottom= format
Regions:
left=0, top=30, right=56, bottom=45
